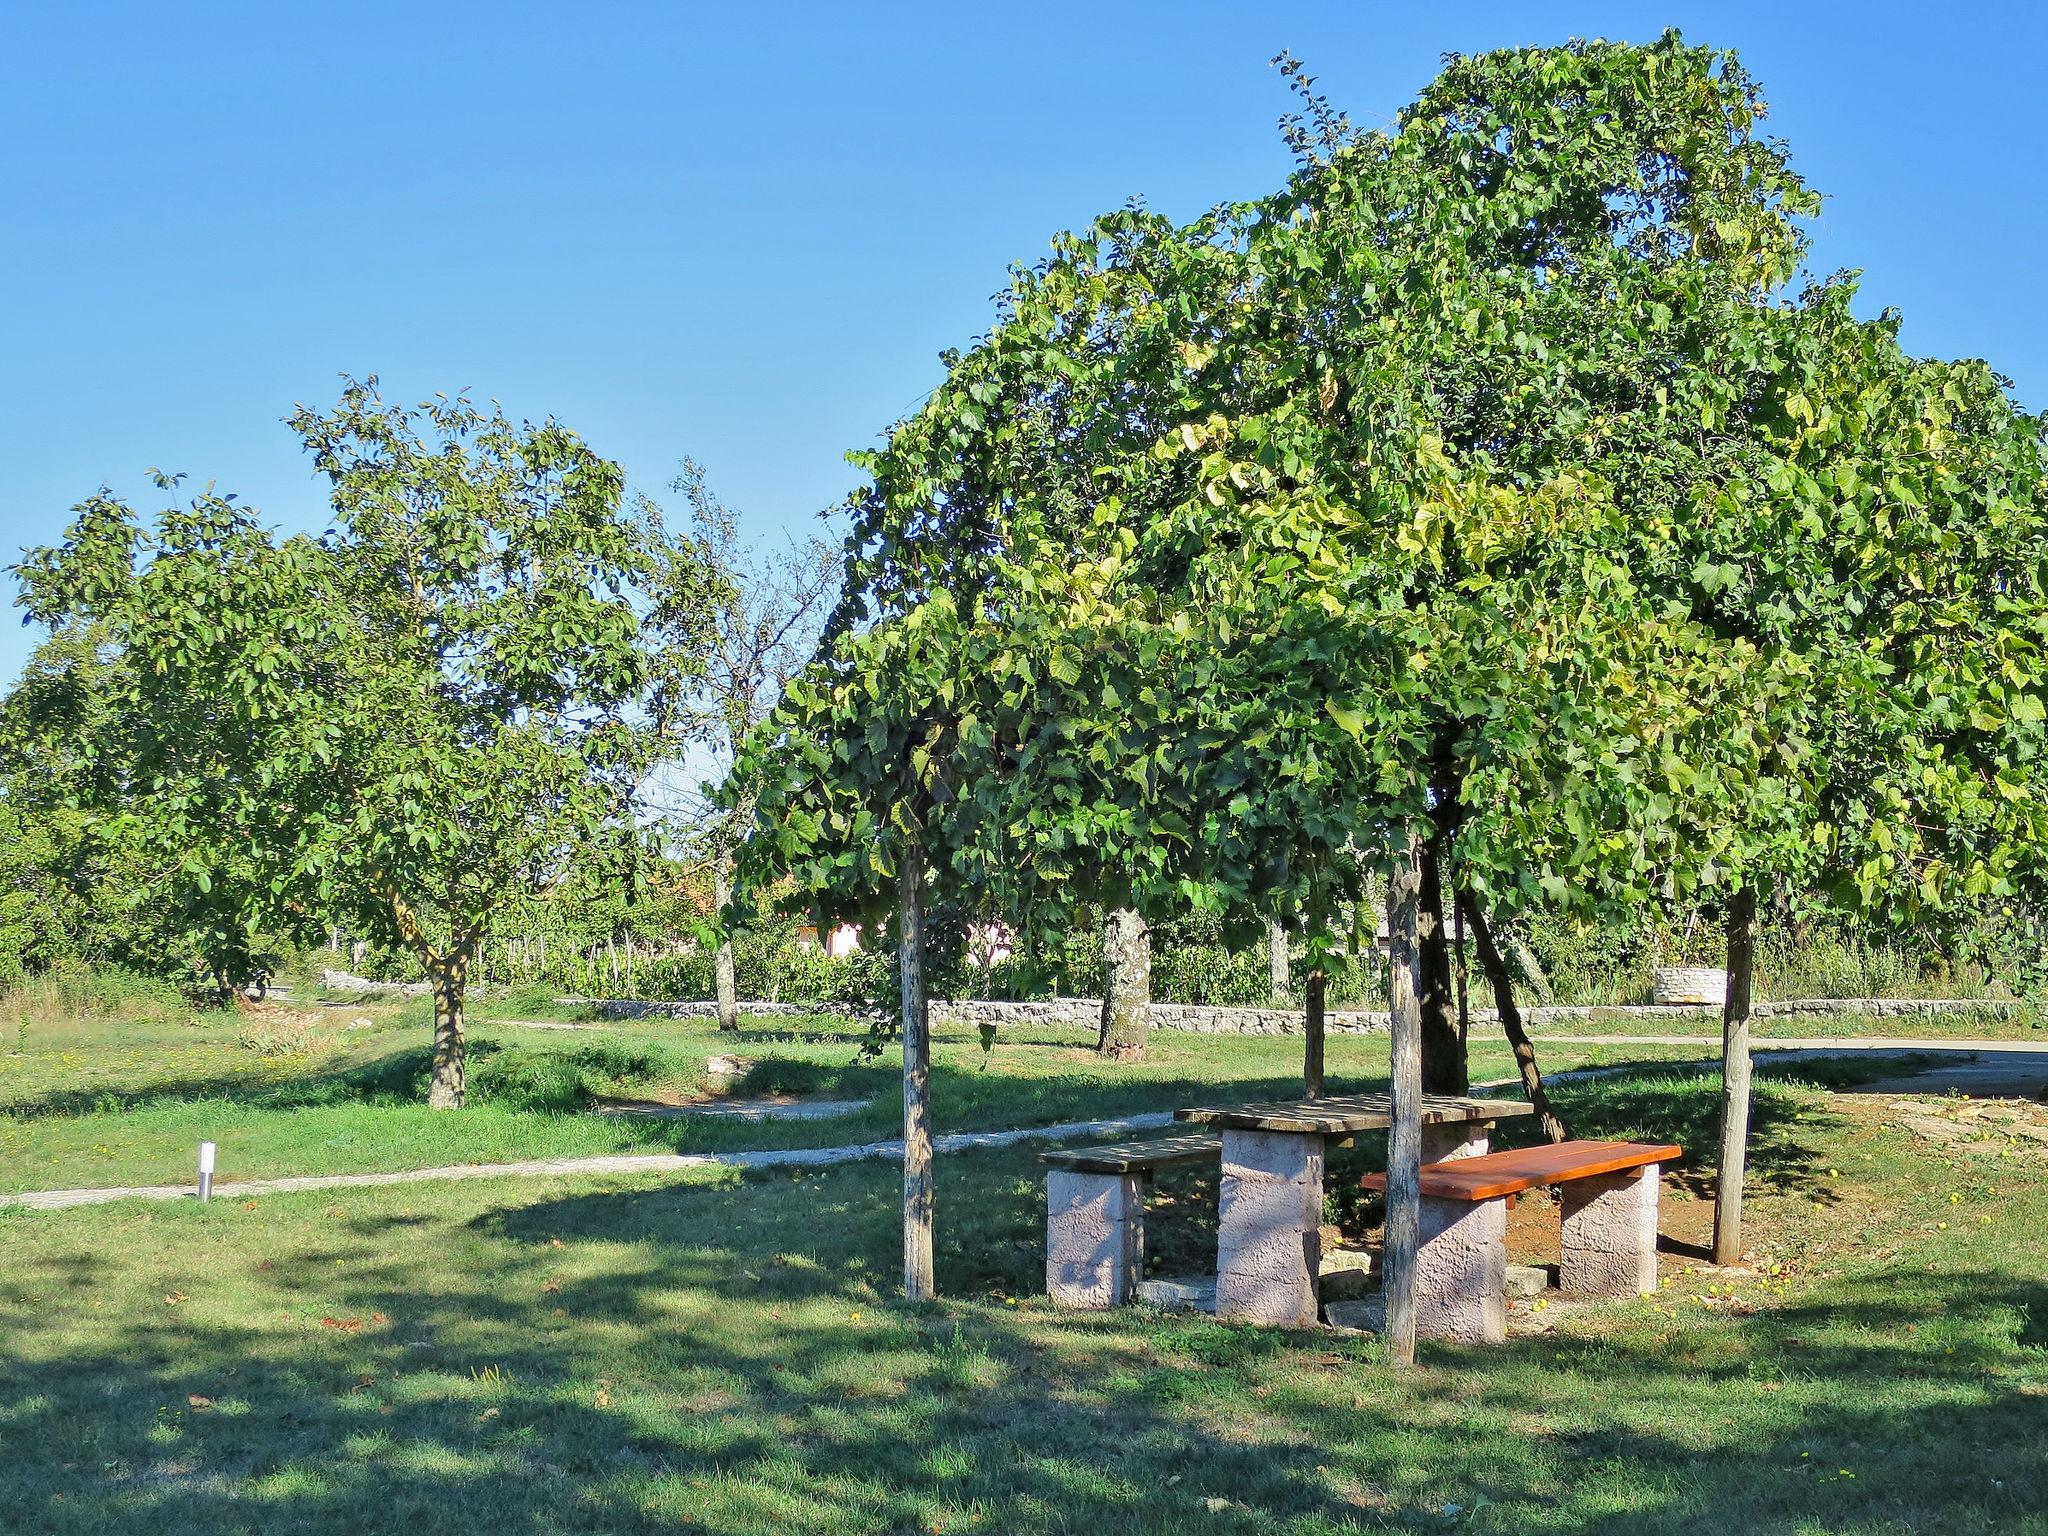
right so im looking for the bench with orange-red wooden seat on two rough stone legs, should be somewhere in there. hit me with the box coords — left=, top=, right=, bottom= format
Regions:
left=1362, top=1141, right=1683, bottom=1343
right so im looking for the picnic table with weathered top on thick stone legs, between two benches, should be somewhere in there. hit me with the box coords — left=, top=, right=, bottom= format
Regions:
left=1174, top=1094, right=1534, bottom=1327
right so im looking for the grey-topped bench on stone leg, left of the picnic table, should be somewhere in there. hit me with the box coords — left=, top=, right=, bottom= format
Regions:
left=1040, top=1135, right=1223, bottom=1309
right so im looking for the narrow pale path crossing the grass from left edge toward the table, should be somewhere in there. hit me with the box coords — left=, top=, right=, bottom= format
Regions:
left=0, top=1110, right=1174, bottom=1210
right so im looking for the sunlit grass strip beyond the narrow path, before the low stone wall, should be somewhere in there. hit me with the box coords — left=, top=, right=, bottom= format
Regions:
left=0, top=1004, right=1686, bottom=1192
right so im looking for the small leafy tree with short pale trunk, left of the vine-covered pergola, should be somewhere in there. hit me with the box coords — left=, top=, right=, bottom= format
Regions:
left=20, top=379, right=663, bottom=1108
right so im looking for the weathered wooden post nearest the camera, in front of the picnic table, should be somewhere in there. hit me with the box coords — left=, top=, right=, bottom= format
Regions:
left=1386, top=831, right=1423, bottom=1366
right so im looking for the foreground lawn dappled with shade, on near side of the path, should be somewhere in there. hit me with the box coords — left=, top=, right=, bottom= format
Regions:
left=0, top=1042, right=2048, bottom=1536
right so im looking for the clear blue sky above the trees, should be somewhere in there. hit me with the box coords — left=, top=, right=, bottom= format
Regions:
left=0, top=0, right=2048, bottom=680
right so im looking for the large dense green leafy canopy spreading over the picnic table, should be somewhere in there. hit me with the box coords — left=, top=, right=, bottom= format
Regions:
left=745, top=35, right=2040, bottom=1085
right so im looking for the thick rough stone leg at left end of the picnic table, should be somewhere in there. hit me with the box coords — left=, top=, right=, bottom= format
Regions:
left=1217, top=1130, right=1323, bottom=1327
